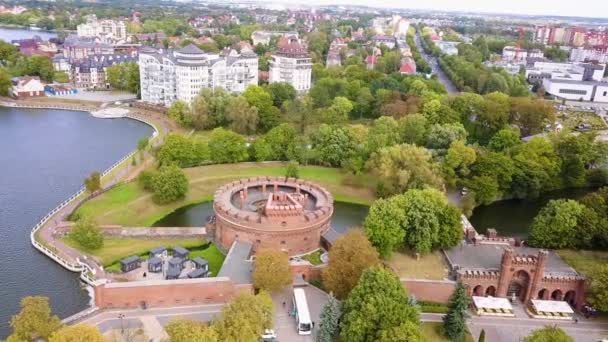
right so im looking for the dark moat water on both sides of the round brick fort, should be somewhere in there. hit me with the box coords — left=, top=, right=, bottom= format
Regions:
left=154, top=202, right=369, bottom=232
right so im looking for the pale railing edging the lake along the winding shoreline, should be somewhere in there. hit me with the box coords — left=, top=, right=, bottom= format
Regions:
left=26, top=107, right=159, bottom=286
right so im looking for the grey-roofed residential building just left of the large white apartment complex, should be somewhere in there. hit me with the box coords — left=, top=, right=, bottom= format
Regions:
left=69, top=54, right=137, bottom=89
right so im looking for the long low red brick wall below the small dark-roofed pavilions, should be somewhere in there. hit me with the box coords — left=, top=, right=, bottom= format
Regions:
left=95, top=277, right=252, bottom=309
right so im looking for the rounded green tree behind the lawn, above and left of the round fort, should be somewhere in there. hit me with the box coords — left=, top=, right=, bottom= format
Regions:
left=209, top=128, right=249, bottom=163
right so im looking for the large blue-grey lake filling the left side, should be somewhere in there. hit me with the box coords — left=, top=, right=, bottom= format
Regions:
left=0, top=107, right=152, bottom=339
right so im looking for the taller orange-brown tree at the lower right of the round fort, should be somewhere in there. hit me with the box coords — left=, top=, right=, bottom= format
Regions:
left=321, top=230, right=380, bottom=299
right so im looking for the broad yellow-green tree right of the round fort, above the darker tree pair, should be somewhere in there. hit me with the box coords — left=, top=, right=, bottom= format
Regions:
left=367, top=144, right=443, bottom=196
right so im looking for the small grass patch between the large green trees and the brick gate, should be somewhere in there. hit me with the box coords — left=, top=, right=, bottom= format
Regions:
left=388, top=251, right=448, bottom=280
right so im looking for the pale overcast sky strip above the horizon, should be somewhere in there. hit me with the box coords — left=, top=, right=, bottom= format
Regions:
left=302, top=0, right=608, bottom=18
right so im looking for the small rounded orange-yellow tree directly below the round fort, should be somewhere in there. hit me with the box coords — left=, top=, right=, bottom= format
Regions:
left=253, top=249, right=292, bottom=292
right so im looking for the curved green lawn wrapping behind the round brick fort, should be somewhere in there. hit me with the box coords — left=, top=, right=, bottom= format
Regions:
left=77, top=162, right=375, bottom=227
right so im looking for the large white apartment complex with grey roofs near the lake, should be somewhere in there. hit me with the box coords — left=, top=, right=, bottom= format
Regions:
left=139, top=44, right=258, bottom=106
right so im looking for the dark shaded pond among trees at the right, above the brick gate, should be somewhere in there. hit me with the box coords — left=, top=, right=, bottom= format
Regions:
left=469, top=188, right=597, bottom=239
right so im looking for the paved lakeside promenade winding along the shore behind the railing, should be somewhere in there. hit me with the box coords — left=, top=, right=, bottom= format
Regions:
left=33, top=107, right=174, bottom=279
